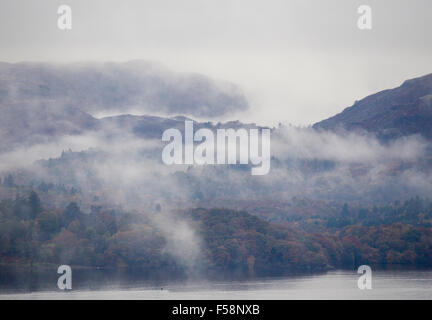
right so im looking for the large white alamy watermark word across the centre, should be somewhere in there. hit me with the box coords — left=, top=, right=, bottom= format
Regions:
left=162, top=120, right=270, bottom=175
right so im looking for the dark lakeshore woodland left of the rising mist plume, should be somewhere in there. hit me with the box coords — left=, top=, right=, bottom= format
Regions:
left=0, top=192, right=176, bottom=268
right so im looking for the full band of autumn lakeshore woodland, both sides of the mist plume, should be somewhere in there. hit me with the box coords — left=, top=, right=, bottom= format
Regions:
left=0, top=192, right=432, bottom=276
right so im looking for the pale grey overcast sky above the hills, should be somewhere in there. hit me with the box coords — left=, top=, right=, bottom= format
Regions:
left=0, top=0, right=432, bottom=125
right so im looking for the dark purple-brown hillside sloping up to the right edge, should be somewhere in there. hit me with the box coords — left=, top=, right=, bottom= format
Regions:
left=313, top=74, right=432, bottom=141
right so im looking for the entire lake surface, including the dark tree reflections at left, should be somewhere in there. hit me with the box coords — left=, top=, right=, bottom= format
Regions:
left=0, top=269, right=432, bottom=300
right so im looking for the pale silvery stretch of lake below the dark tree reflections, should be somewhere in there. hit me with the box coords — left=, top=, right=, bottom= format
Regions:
left=0, top=271, right=432, bottom=300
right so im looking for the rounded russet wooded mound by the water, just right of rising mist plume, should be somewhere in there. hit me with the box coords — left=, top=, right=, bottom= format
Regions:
left=185, top=209, right=331, bottom=275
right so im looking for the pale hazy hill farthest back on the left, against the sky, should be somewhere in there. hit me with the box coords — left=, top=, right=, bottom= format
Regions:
left=0, top=61, right=248, bottom=117
